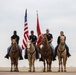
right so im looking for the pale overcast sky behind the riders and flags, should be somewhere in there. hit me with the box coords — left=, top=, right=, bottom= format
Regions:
left=0, top=0, right=76, bottom=67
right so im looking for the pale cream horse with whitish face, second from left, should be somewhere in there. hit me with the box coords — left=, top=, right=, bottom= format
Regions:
left=27, top=40, right=36, bottom=72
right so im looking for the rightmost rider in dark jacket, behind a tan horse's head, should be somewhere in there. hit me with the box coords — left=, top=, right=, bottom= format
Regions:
left=55, top=31, right=71, bottom=58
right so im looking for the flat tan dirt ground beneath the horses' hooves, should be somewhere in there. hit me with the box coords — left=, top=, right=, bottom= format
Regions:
left=0, top=67, right=76, bottom=75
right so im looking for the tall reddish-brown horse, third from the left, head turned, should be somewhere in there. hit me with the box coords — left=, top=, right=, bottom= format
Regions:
left=41, top=34, right=53, bottom=72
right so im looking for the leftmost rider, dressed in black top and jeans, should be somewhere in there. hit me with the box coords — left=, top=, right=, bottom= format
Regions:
left=5, top=31, right=23, bottom=60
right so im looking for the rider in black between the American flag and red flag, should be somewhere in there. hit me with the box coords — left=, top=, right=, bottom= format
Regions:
left=25, top=30, right=39, bottom=59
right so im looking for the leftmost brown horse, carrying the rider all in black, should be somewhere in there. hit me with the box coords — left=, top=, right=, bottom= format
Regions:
left=9, top=39, right=19, bottom=72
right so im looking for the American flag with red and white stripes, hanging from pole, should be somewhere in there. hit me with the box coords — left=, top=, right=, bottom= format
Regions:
left=22, top=9, right=29, bottom=49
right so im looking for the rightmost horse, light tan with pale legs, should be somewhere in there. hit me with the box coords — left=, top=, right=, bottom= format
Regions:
left=57, top=36, right=67, bottom=72
